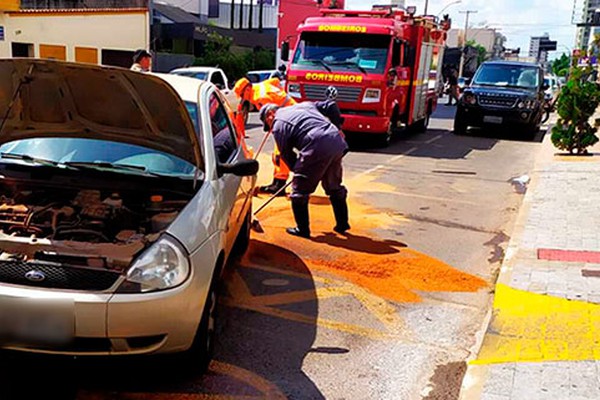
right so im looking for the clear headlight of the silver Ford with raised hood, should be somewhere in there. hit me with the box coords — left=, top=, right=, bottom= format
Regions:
left=127, top=236, right=190, bottom=293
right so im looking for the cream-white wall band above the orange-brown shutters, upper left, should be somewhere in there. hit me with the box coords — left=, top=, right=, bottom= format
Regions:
left=0, top=12, right=150, bottom=61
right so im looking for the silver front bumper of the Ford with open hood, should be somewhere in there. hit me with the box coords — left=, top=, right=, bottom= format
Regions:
left=0, top=270, right=205, bottom=355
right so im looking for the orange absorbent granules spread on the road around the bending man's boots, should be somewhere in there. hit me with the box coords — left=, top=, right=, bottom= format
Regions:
left=246, top=170, right=487, bottom=302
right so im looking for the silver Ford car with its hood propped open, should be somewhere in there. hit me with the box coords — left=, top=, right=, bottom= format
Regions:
left=0, top=59, right=258, bottom=368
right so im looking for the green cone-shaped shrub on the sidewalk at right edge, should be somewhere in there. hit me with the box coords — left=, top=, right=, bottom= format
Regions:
left=551, top=67, right=600, bottom=154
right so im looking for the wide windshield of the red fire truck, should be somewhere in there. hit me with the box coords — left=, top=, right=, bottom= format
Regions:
left=293, top=32, right=391, bottom=74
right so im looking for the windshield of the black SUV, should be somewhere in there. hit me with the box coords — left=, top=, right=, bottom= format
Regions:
left=473, top=65, right=540, bottom=89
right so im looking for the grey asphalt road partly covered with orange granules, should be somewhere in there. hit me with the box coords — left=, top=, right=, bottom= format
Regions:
left=0, top=105, right=542, bottom=400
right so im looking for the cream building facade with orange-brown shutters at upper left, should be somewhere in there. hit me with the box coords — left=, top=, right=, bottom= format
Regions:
left=0, top=0, right=150, bottom=67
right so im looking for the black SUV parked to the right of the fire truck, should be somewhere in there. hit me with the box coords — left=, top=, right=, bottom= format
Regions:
left=454, top=61, right=545, bottom=135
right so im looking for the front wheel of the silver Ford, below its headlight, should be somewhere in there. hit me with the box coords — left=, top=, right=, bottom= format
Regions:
left=181, top=280, right=218, bottom=374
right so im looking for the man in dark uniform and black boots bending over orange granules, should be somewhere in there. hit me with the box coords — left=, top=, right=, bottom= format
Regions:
left=260, top=102, right=350, bottom=238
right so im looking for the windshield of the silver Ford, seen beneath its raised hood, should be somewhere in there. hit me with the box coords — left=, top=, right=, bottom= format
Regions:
left=0, top=138, right=196, bottom=179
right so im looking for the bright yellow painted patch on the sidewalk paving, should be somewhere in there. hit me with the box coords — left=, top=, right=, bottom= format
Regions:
left=472, top=285, right=600, bottom=364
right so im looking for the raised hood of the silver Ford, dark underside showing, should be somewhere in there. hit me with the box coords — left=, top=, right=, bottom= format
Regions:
left=0, top=59, right=202, bottom=167
